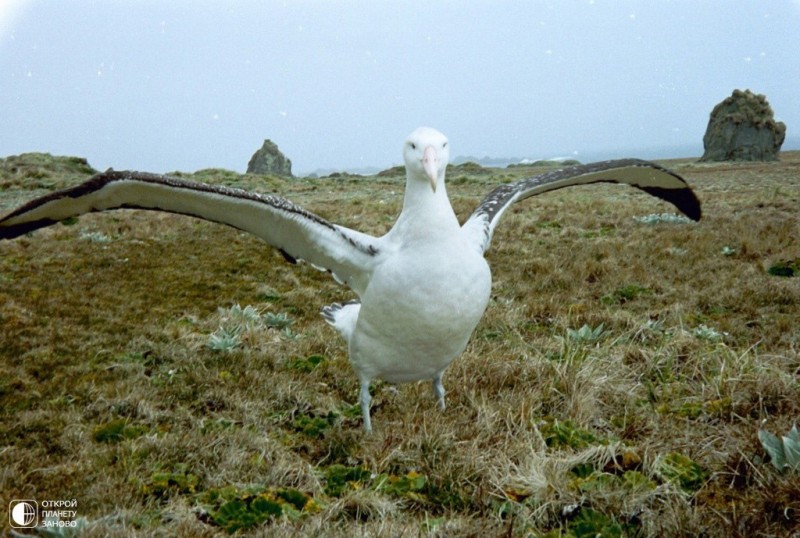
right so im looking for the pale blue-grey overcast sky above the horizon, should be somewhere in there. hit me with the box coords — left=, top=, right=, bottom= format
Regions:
left=0, top=0, right=800, bottom=173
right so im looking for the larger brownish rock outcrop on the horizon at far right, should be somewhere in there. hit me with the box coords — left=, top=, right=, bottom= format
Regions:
left=700, top=90, right=786, bottom=161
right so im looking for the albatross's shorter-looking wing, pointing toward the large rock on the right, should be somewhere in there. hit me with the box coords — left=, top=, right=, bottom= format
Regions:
left=462, top=159, right=701, bottom=252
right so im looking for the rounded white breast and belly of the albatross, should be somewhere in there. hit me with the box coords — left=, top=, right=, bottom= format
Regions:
left=350, top=237, right=491, bottom=383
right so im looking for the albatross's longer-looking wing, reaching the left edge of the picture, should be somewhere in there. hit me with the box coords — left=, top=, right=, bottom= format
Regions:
left=0, top=171, right=378, bottom=294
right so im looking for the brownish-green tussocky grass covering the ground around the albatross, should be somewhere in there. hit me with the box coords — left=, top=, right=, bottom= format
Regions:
left=0, top=153, right=800, bottom=536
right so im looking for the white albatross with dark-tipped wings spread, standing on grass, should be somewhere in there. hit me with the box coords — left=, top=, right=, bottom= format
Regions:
left=0, top=127, right=701, bottom=432
